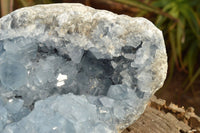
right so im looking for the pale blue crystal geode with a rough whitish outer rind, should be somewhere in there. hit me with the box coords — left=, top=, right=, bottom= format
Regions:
left=0, top=4, right=167, bottom=133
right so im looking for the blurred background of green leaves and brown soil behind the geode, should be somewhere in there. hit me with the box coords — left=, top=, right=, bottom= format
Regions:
left=0, top=0, right=200, bottom=115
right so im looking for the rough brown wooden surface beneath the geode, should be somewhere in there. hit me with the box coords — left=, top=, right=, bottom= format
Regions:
left=122, top=96, right=200, bottom=133
